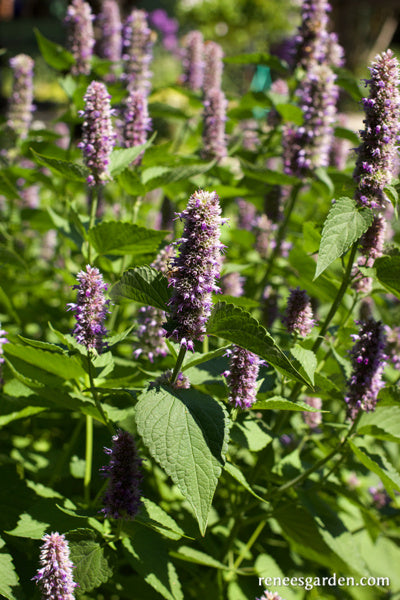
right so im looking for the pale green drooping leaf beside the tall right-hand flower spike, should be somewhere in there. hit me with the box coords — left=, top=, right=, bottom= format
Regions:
left=314, top=198, right=373, bottom=280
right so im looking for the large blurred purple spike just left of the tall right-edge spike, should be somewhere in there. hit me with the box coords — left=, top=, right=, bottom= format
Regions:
left=282, top=63, right=339, bottom=177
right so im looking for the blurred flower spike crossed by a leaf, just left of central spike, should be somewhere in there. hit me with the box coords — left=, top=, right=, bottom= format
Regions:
left=133, top=245, right=174, bottom=362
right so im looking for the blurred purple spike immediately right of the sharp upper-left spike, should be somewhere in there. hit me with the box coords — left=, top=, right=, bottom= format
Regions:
left=124, top=90, right=151, bottom=165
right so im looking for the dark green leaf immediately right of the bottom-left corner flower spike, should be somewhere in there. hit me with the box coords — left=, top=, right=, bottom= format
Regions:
left=65, top=529, right=112, bottom=592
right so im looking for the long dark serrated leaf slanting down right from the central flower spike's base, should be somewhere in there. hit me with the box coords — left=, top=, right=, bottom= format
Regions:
left=207, top=302, right=309, bottom=385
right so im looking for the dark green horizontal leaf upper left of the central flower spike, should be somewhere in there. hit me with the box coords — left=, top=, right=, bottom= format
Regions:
left=88, top=221, right=168, bottom=256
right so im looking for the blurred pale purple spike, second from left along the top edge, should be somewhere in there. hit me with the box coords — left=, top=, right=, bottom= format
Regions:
left=97, top=0, right=122, bottom=82
